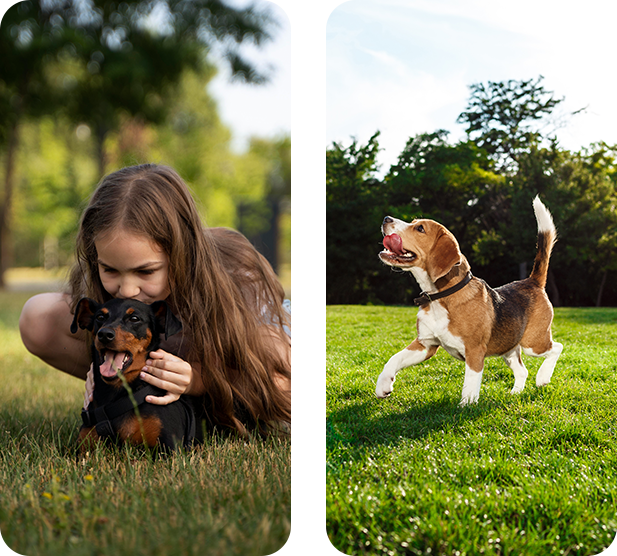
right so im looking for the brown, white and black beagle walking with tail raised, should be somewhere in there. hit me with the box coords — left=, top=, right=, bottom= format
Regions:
left=375, top=197, right=563, bottom=406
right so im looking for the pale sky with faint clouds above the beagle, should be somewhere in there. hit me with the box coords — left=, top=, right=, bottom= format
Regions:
left=325, top=0, right=617, bottom=173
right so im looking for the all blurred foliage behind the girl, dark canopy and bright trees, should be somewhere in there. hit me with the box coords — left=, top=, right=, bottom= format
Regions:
left=0, top=0, right=286, bottom=287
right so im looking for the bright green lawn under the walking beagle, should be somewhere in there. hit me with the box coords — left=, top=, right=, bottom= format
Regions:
left=325, top=306, right=617, bottom=556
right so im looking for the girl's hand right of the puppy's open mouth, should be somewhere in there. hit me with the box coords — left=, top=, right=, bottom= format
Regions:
left=139, top=349, right=193, bottom=405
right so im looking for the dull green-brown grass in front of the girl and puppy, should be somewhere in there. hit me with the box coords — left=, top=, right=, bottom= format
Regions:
left=0, top=293, right=291, bottom=556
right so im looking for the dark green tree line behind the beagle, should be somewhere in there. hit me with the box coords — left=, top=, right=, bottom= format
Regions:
left=326, top=78, right=617, bottom=305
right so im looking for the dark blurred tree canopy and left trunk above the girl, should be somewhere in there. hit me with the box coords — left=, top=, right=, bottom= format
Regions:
left=0, top=0, right=275, bottom=287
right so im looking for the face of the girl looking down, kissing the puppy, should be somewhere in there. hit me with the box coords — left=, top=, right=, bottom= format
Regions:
left=94, top=229, right=170, bottom=303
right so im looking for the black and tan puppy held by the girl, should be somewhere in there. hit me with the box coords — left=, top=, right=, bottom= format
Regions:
left=71, top=298, right=199, bottom=451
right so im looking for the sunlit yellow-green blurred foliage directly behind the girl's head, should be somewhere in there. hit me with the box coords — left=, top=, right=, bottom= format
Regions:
left=13, top=68, right=291, bottom=266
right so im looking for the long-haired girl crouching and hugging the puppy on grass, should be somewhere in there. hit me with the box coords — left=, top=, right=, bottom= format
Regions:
left=20, top=164, right=291, bottom=434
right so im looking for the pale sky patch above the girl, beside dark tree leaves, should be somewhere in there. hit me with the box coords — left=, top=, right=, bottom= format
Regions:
left=208, top=0, right=292, bottom=152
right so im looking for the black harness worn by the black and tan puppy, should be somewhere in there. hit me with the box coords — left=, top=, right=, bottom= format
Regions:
left=81, top=385, right=196, bottom=448
